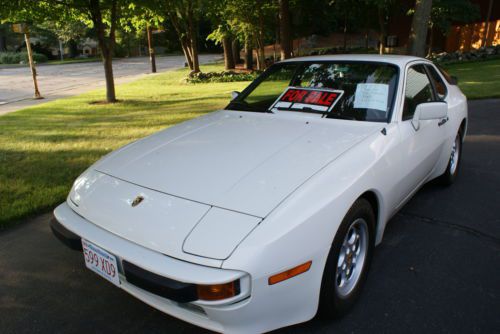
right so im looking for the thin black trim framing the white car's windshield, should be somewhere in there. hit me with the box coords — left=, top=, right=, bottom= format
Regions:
left=224, top=60, right=401, bottom=123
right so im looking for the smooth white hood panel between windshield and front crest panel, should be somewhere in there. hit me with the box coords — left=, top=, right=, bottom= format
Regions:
left=94, top=111, right=384, bottom=218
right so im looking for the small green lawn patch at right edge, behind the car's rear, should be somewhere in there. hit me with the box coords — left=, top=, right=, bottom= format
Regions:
left=445, top=59, right=500, bottom=100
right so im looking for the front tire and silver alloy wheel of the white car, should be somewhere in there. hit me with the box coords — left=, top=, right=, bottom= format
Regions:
left=318, top=198, right=375, bottom=318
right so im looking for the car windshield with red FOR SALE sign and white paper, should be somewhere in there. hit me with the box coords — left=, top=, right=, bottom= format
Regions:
left=226, top=61, right=398, bottom=122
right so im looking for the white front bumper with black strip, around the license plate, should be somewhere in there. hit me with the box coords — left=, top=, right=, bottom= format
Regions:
left=51, top=203, right=254, bottom=332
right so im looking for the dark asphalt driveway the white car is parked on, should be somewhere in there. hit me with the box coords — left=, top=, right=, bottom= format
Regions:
left=0, top=100, right=500, bottom=334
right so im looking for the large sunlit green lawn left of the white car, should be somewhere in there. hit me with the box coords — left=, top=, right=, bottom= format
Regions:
left=0, top=65, right=248, bottom=228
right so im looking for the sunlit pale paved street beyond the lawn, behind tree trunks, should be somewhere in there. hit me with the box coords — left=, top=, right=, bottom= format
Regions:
left=0, top=55, right=220, bottom=115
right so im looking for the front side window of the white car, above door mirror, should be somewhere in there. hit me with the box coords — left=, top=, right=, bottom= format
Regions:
left=403, top=65, right=434, bottom=121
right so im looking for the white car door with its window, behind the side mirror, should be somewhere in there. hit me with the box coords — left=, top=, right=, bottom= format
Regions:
left=399, top=64, right=446, bottom=205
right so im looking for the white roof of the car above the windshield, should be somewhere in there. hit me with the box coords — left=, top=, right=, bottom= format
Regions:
left=283, top=54, right=430, bottom=67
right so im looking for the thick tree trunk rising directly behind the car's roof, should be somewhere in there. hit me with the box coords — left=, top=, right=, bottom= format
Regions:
left=408, top=0, right=432, bottom=57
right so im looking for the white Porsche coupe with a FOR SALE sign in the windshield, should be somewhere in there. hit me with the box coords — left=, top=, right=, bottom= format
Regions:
left=51, top=55, right=467, bottom=333
